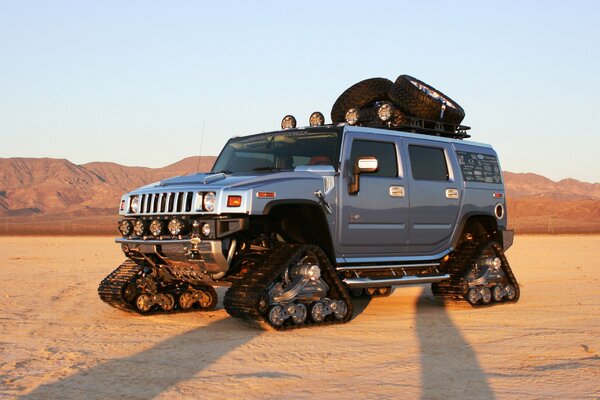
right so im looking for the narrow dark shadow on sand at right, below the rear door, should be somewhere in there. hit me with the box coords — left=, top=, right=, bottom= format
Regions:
left=415, top=286, right=495, bottom=399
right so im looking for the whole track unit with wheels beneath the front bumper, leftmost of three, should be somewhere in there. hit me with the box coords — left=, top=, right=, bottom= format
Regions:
left=98, top=260, right=218, bottom=314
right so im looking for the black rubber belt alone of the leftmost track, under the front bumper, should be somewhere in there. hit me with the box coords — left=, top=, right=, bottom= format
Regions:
left=98, top=260, right=217, bottom=315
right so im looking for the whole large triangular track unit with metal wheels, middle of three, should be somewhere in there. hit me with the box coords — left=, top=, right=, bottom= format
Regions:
left=223, top=244, right=352, bottom=330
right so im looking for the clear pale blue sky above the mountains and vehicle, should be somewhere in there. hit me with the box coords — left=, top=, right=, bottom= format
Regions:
left=0, top=0, right=600, bottom=182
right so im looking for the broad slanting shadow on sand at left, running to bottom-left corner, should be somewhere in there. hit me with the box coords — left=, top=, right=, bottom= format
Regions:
left=25, top=299, right=369, bottom=399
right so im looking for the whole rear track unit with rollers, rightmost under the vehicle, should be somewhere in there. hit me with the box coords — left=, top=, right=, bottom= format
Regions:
left=431, top=235, right=520, bottom=306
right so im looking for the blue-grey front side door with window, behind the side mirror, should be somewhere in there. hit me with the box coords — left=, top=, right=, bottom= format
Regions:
left=338, top=133, right=408, bottom=257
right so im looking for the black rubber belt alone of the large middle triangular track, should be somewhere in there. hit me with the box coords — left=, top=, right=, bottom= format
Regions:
left=223, top=244, right=352, bottom=330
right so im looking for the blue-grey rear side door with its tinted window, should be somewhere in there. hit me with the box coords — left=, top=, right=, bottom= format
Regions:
left=404, top=139, right=463, bottom=254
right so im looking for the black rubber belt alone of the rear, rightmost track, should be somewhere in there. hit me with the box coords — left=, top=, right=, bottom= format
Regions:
left=431, top=241, right=520, bottom=307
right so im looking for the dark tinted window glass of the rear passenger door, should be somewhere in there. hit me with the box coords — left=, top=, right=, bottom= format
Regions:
left=408, top=145, right=448, bottom=181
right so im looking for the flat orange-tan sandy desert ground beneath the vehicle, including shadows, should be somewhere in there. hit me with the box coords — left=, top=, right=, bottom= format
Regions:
left=0, top=236, right=600, bottom=399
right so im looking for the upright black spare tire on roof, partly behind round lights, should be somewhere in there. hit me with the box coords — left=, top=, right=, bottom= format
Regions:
left=331, top=78, right=393, bottom=124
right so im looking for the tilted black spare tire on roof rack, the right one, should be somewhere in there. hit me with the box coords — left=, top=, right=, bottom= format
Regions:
left=390, top=75, right=465, bottom=125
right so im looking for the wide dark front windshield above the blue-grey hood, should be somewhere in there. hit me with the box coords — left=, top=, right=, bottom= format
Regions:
left=212, top=131, right=339, bottom=174
